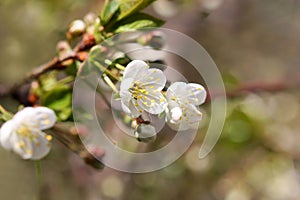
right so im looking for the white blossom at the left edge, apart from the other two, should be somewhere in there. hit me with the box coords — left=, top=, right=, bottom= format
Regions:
left=0, top=107, right=56, bottom=160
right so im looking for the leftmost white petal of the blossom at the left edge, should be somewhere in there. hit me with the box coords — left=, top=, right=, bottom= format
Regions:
left=0, top=120, right=16, bottom=150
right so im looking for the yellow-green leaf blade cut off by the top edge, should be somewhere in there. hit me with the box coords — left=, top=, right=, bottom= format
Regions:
left=118, top=0, right=155, bottom=20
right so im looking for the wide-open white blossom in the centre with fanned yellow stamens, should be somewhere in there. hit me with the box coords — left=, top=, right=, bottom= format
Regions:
left=120, top=60, right=167, bottom=117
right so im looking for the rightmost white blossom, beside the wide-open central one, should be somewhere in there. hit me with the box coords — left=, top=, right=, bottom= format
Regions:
left=166, top=82, right=206, bottom=130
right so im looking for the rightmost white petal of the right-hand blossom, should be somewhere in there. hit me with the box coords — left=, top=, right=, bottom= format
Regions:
left=188, top=83, right=206, bottom=105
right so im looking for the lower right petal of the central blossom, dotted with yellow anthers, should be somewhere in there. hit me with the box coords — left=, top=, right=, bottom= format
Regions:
left=137, top=92, right=167, bottom=115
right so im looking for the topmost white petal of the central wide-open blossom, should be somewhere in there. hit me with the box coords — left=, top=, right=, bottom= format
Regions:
left=123, top=60, right=148, bottom=80
